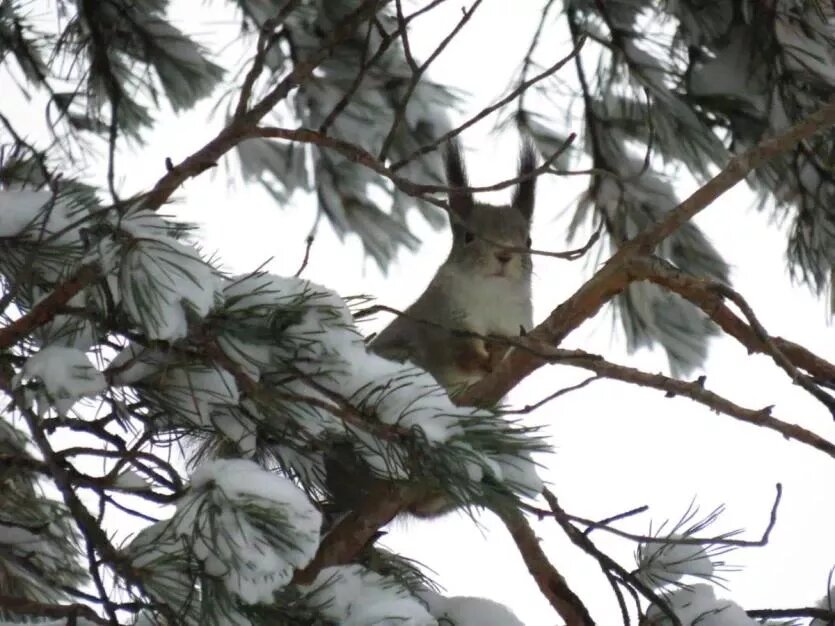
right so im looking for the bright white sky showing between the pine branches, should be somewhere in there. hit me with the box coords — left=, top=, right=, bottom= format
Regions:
left=3, top=0, right=835, bottom=626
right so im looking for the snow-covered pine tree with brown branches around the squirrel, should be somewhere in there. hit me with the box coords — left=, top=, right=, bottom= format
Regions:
left=0, top=0, right=835, bottom=626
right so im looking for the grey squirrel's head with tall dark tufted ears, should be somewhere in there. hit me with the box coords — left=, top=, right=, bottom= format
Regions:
left=444, top=142, right=536, bottom=280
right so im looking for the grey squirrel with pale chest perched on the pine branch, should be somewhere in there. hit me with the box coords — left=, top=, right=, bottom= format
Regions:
left=326, top=142, right=536, bottom=518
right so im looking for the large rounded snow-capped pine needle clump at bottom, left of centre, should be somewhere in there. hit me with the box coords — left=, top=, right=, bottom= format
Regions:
left=128, top=459, right=322, bottom=623
